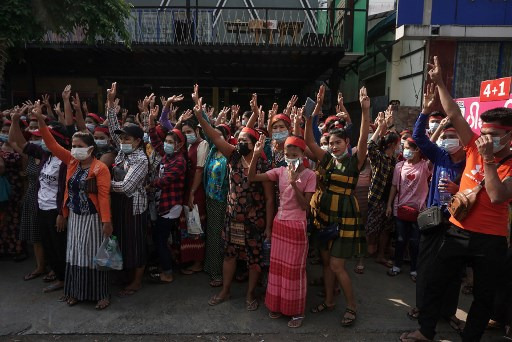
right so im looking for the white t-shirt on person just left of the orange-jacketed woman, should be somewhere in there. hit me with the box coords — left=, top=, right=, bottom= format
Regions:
left=37, top=156, right=62, bottom=210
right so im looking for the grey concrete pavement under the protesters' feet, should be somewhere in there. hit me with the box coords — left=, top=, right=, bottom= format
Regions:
left=0, top=255, right=500, bottom=342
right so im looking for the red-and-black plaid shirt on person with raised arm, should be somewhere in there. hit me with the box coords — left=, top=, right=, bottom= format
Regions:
left=149, top=128, right=187, bottom=216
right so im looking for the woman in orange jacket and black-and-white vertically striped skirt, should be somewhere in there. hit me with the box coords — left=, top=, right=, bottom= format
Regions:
left=34, top=101, right=112, bottom=310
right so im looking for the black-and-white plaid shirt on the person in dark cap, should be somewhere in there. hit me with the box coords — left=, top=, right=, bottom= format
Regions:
left=107, top=108, right=149, bottom=215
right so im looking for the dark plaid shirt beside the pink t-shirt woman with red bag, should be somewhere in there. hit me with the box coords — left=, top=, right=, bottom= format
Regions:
left=368, top=140, right=396, bottom=205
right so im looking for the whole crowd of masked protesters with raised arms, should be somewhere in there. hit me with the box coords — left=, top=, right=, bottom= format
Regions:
left=0, top=57, right=512, bottom=342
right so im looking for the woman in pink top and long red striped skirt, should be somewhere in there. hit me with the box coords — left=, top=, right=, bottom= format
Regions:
left=248, top=136, right=316, bottom=328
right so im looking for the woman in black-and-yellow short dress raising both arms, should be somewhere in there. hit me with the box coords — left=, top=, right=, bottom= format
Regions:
left=306, top=86, right=370, bottom=326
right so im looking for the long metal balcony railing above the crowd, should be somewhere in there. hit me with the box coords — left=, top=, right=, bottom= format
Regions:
left=45, top=6, right=365, bottom=51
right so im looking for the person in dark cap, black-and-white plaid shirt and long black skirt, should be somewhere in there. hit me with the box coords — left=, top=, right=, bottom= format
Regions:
left=107, top=82, right=149, bottom=297
